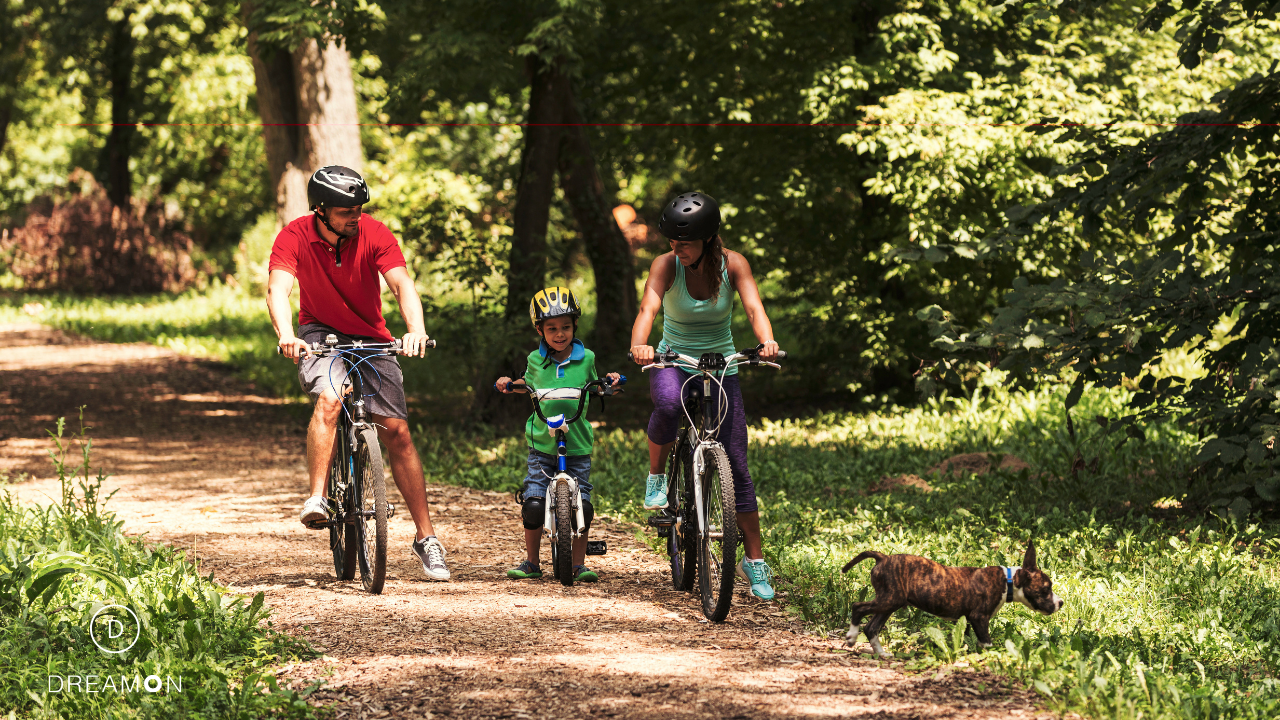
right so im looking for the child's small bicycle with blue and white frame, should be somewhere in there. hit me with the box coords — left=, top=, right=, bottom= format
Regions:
left=494, top=375, right=627, bottom=587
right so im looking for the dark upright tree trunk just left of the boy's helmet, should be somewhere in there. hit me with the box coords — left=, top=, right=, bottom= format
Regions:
left=472, top=55, right=571, bottom=427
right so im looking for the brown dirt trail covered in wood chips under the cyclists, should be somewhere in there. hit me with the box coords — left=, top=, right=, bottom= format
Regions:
left=0, top=324, right=1036, bottom=719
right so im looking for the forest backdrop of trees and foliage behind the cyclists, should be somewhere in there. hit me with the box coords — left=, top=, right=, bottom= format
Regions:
left=0, top=0, right=1280, bottom=509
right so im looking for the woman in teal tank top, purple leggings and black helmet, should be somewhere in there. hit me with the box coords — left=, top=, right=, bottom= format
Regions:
left=631, top=192, right=778, bottom=600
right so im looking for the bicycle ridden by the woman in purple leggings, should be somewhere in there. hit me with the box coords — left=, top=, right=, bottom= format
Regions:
left=643, top=346, right=786, bottom=623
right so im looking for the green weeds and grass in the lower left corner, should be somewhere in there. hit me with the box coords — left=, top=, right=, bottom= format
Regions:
left=0, top=420, right=321, bottom=720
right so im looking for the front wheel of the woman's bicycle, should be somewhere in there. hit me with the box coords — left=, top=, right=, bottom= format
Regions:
left=698, top=447, right=737, bottom=623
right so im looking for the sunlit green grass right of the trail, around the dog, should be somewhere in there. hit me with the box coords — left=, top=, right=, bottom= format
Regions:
left=420, top=375, right=1280, bottom=717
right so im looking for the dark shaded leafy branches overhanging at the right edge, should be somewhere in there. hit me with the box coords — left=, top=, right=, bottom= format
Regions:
left=920, top=3, right=1280, bottom=504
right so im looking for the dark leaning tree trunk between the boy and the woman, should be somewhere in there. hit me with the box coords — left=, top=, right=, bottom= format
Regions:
left=559, top=97, right=636, bottom=368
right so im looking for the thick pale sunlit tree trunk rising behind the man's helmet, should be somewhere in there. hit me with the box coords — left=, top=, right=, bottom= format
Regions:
left=244, top=27, right=364, bottom=224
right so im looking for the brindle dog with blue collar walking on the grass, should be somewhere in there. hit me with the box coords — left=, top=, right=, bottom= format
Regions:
left=841, top=542, right=1062, bottom=657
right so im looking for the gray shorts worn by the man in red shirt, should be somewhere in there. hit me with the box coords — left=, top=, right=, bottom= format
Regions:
left=298, top=323, right=408, bottom=420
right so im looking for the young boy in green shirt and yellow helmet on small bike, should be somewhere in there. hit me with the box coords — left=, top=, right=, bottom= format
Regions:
left=494, top=287, right=620, bottom=583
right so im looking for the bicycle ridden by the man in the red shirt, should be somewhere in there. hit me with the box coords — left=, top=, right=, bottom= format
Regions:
left=275, top=334, right=435, bottom=594
